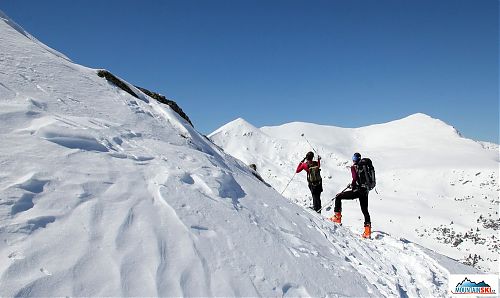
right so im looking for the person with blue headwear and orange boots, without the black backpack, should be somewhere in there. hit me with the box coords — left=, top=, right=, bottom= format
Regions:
left=330, top=152, right=371, bottom=238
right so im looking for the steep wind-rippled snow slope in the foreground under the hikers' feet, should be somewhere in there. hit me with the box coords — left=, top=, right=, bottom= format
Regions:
left=0, top=8, right=484, bottom=297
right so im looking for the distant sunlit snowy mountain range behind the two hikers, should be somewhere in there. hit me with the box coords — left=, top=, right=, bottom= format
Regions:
left=209, top=114, right=500, bottom=272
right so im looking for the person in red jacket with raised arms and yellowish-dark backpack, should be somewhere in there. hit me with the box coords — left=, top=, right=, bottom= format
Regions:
left=295, top=152, right=323, bottom=213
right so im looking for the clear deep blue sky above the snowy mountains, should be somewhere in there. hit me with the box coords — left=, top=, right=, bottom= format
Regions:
left=0, top=0, right=499, bottom=143
